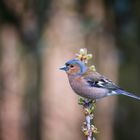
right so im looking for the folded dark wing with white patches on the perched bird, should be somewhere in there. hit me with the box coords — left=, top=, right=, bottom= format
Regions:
left=85, top=72, right=119, bottom=90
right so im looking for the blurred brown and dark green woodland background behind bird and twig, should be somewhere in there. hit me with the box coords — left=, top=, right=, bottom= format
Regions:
left=0, top=0, right=140, bottom=140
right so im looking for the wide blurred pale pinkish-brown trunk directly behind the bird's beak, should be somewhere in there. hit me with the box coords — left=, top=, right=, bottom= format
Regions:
left=42, top=0, right=84, bottom=140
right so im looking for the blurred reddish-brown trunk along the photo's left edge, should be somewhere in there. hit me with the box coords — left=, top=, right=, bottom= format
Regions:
left=0, top=25, right=24, bottom=140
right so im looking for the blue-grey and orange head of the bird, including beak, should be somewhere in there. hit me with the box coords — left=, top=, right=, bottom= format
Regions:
left=60, top=59, right=88, bottom=75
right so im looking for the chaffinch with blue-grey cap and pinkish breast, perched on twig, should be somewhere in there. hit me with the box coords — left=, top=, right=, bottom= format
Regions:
left=60, top=59, right=140, bottom=100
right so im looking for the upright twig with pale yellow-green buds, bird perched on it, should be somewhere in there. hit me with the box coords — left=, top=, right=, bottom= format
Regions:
left=76, top=48, right=99, bottom=140
